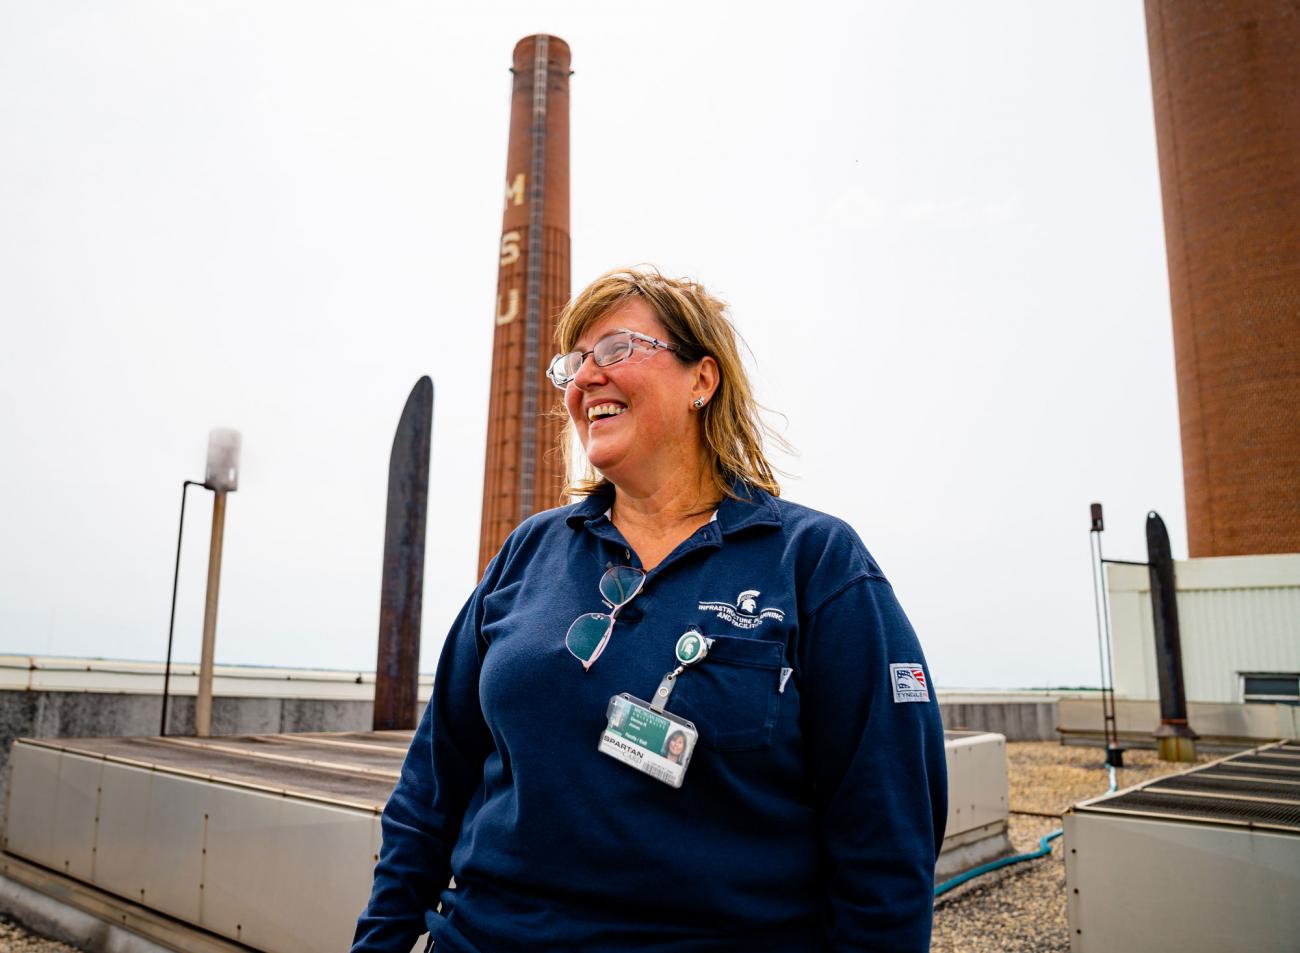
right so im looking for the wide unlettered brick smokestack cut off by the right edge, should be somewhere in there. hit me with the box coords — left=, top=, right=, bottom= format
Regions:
left=1147, top=0, right=1300, bottom=556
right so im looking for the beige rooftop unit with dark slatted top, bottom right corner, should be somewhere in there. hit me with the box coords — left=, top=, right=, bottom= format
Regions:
left=1065, top=741, right=1300, bottom=953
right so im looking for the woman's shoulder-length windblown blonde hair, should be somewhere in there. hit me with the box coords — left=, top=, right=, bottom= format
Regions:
left=555, top=267, right=790, bottom=499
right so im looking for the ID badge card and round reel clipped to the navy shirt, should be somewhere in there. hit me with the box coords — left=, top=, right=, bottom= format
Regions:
left=598, top=631, right=710, bottom=788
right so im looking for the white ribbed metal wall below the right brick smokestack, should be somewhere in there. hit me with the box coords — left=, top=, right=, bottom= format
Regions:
left=1106, top=555, right=1300, bottom=702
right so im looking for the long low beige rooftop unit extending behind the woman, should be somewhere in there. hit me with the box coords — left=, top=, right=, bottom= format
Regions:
left=0, top=731, right=1011, bottom=953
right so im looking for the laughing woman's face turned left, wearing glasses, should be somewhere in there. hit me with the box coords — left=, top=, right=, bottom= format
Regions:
left=564, top=298, right=711, bottom=488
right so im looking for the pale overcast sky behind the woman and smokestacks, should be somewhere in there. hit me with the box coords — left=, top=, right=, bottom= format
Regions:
left=0, top=0, right=1186, bottom=688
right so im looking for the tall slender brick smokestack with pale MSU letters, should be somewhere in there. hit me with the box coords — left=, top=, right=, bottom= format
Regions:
left=478, top=35, right=569, bottom=573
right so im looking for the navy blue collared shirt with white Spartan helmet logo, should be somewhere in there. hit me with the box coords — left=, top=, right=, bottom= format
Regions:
left=354, top=486, right=946, bottom=953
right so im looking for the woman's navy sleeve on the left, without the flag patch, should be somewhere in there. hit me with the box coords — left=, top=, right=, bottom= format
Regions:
left=352, top=586, right=491, bottom=953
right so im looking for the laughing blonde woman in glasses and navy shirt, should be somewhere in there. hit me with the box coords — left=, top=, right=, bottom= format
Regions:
left=354, top=270, right=946, bottom=953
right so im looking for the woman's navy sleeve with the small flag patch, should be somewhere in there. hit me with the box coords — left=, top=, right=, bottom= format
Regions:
left=802, top=576, right=948, bottom=953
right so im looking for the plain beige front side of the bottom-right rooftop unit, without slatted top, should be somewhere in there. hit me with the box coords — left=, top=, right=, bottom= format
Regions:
left=1065, top=813, right=1300, bottom=953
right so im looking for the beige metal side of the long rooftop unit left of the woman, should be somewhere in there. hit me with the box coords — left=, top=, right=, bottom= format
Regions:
left=7, top=742, right=424, bottom=953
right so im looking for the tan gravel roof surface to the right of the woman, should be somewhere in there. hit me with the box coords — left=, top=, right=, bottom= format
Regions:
left=931, top=741, right=1222, bottom=953
